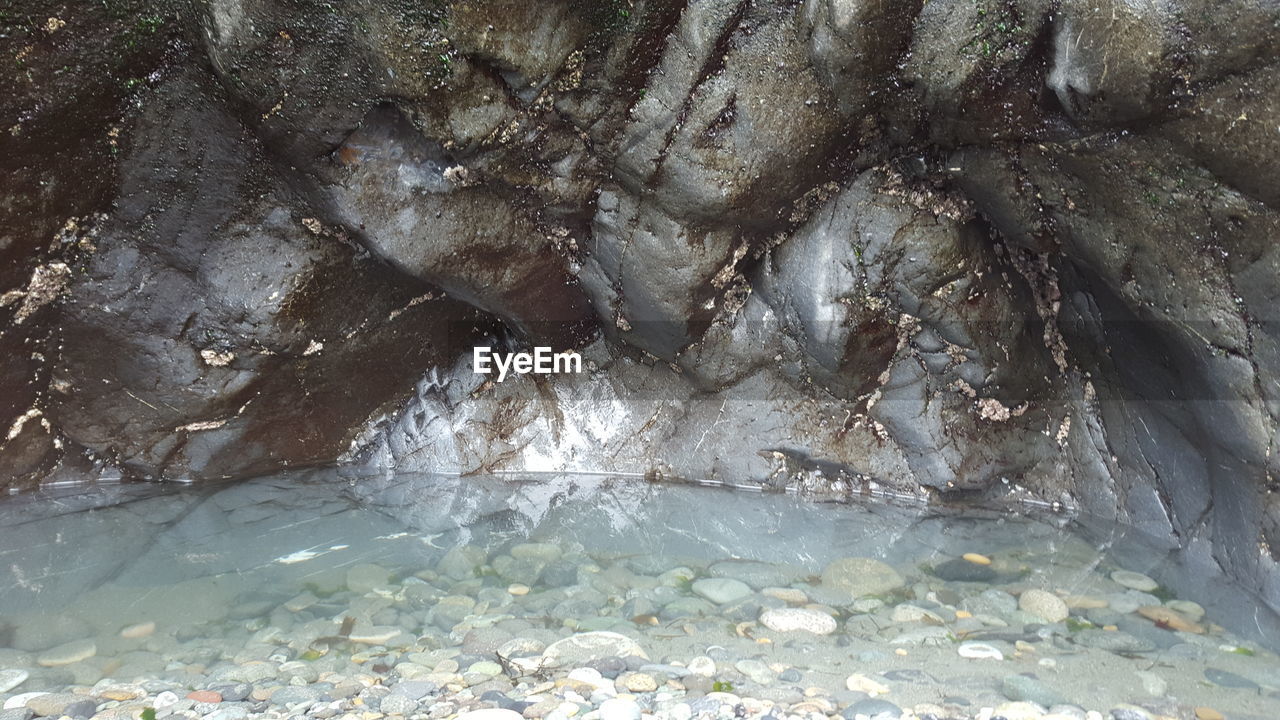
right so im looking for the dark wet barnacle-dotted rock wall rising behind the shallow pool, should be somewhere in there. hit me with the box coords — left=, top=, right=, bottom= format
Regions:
left=0, top=0, right=1280, bottom=620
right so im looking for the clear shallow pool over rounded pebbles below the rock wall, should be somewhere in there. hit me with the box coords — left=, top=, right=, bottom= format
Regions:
left=0, top=471, right=1280, bottom=720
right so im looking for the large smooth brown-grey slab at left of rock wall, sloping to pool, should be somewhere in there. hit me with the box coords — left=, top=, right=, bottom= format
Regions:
left=46, top=73, right=481, bottom=478
